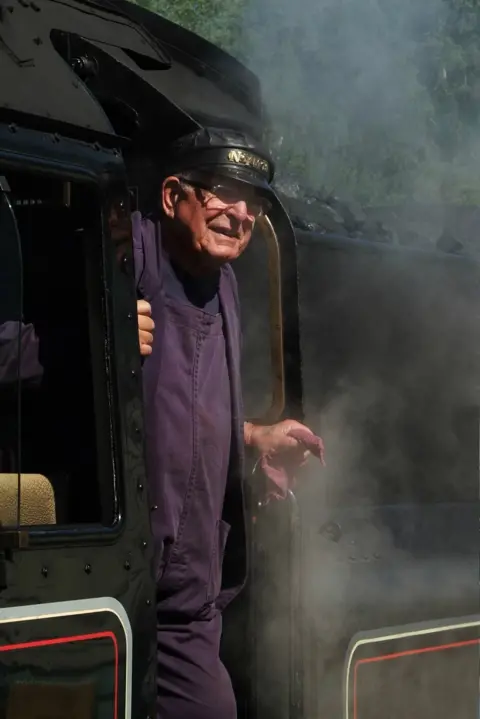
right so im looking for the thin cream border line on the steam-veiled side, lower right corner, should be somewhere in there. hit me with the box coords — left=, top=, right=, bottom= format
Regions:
left=344, top=614, right=480, bottom=719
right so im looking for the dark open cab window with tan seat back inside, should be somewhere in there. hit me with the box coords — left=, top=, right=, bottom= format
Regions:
left=0, top=172, right=116, bottom=526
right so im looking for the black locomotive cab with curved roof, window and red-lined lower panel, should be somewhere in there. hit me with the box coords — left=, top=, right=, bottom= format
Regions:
left=0, top=0, right=300, bottom=719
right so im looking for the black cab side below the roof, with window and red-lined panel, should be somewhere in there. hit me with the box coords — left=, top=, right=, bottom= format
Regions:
left=0, top=136, right=154, bottom=716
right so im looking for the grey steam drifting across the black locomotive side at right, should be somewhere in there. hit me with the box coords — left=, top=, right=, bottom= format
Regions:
left=240, top=207, right=480, bottom=718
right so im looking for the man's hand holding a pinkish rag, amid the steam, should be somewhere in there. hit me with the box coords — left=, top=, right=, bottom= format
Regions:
left=244, top=419, right=313, bottom=465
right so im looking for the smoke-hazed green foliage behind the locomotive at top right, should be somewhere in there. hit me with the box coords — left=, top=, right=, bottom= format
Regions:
left=128, top=0, right=480, bottom=205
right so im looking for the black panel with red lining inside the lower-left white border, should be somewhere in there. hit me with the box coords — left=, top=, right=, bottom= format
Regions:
left=0, top=610, right=128, bottom=717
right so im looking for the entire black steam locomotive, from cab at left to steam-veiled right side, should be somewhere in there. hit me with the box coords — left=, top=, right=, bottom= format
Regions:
left=0, top=0, right=480, bottom=719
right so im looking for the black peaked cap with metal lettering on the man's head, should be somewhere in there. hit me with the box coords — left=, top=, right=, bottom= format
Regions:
left=164, top=127, right=274, bottom=192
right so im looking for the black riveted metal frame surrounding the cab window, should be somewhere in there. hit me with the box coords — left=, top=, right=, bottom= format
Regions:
left=0, top=126, right=155, bottom=717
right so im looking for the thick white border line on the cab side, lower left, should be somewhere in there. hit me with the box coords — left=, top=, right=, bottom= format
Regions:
left=0, top=597, right=133, bottom=719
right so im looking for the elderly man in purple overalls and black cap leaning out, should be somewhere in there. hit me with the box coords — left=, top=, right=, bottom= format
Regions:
left=133, top=129, right=316, bottom=719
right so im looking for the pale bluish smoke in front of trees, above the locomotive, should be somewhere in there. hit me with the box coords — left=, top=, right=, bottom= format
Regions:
left=243, top=0, right=464, bottom=205
